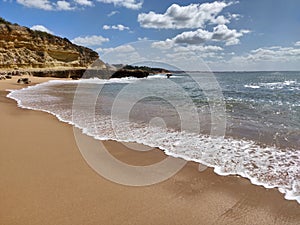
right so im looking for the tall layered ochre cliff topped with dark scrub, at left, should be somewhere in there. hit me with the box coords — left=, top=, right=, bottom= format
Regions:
left=0, top=21, right=101, bottom=69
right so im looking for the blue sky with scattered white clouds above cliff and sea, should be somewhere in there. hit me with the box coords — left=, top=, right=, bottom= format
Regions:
left=0, top=0, right=300, bottom=71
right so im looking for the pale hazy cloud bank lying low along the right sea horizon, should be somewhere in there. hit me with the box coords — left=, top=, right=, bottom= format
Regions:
left=165, top=45, right=300, bottom=71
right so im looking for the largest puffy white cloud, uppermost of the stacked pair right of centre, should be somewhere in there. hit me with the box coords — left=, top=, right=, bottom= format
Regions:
left=138, top=1, right=232, bottom=29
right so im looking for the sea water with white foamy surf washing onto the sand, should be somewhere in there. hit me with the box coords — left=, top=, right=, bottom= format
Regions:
left=8, top=72, right=300, bottom=203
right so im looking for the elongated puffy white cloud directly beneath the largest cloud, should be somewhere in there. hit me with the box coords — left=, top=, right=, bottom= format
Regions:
left=153, top=24, right=250, bottom=48
